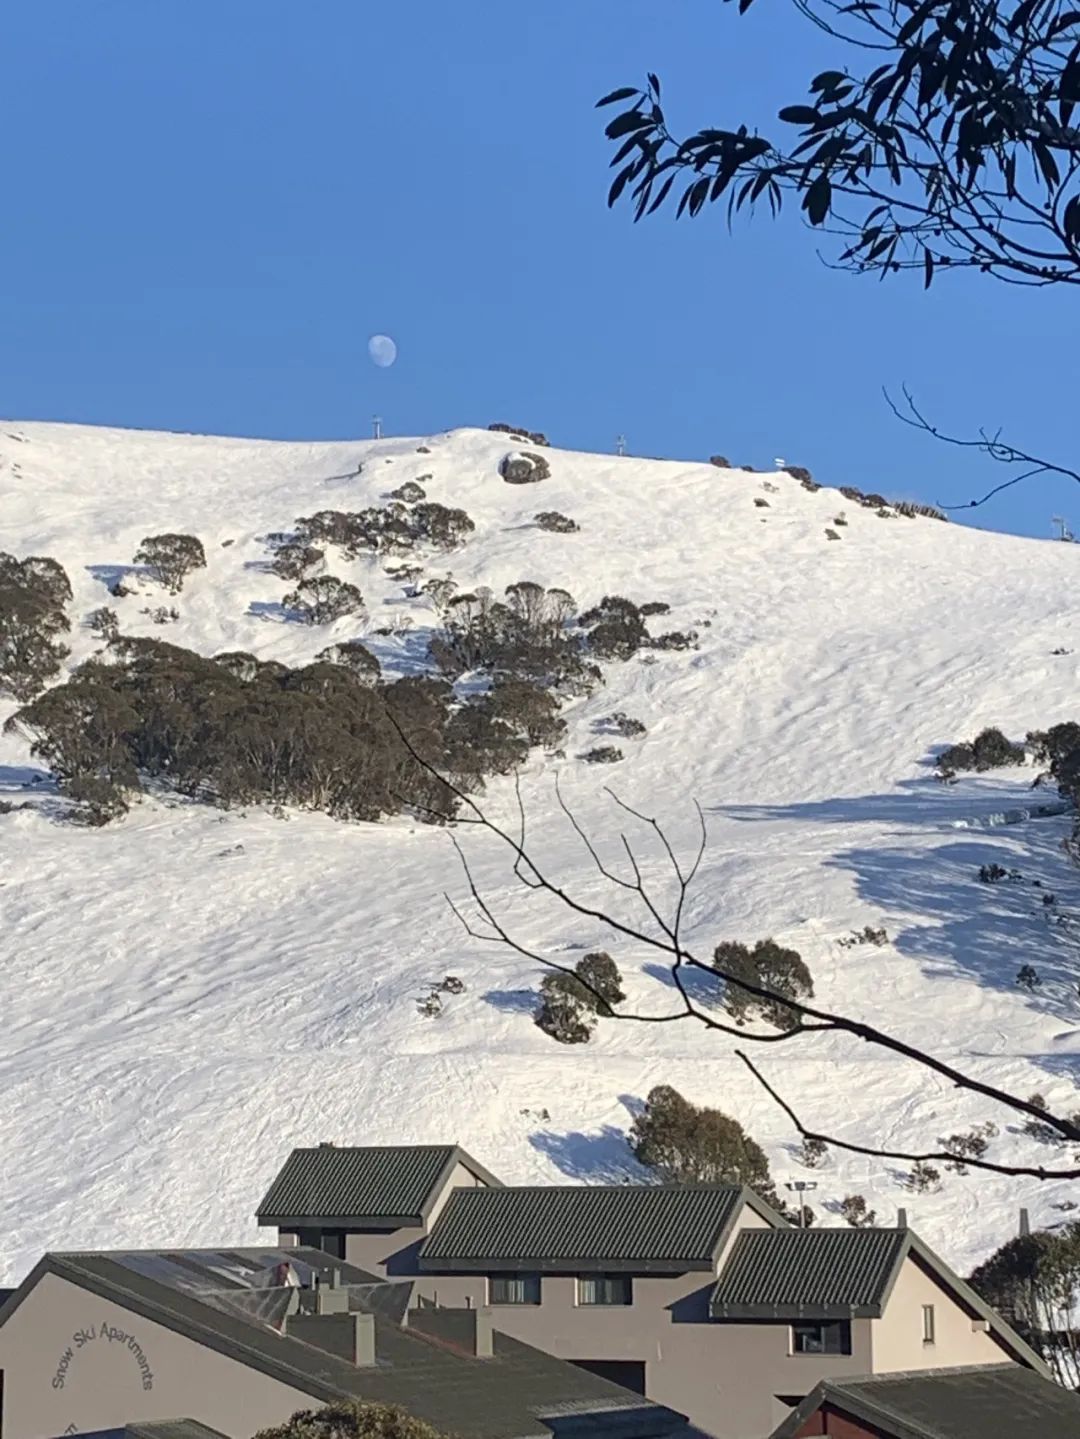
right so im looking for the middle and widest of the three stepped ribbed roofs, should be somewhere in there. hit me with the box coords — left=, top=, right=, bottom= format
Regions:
left=420, top=1184, right=784, bottom=1274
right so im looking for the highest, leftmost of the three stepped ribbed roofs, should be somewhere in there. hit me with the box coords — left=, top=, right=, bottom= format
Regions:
left=256, top=1144, right=499, bottom=1229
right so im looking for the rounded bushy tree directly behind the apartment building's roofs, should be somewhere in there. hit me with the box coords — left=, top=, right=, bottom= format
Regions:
left=630, top=1085, right=778, bottom=1204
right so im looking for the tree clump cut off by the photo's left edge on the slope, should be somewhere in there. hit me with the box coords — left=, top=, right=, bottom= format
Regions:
left=0, top=551, right=72, bottom=701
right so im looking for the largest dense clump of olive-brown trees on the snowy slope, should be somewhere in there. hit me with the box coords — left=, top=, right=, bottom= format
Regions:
left=9, top=637, right=557, bottom=820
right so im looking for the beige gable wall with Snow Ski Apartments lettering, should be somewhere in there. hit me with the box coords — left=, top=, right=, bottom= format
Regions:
left=0, top=1274, right=315, bottom=1439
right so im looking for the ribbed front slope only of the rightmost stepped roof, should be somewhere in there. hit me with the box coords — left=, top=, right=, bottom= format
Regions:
left=712, top=1229, right=910, bottom=1320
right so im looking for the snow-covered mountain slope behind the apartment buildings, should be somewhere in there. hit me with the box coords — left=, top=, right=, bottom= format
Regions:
left=0, top=425, right=1080, bottom=1281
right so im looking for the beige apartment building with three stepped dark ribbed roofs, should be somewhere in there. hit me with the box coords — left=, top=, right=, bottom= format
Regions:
left=257, top=1145, right=1044, bottom=1439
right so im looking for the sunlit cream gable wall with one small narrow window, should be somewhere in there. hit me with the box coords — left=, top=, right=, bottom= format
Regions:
left=871, top=1255, right=1012, bottom=1374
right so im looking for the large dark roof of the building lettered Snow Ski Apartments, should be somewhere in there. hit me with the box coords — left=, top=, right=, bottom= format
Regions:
left=0, top=1248, right=685, bottom=1439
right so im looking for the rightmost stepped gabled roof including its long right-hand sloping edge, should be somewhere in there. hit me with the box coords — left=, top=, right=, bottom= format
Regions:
left=710, top=1229, right=1048, bottom=1374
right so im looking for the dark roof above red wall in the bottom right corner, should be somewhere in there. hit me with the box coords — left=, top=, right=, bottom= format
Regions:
left=772, top=1364, right=1080, bottom=1439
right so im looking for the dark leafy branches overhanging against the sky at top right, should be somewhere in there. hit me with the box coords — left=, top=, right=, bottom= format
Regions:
left=598, top=0, right=1080, bottom=286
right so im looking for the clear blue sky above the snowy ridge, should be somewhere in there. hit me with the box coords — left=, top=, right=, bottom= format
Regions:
left=0, top=0, right=1080, bottom=535
